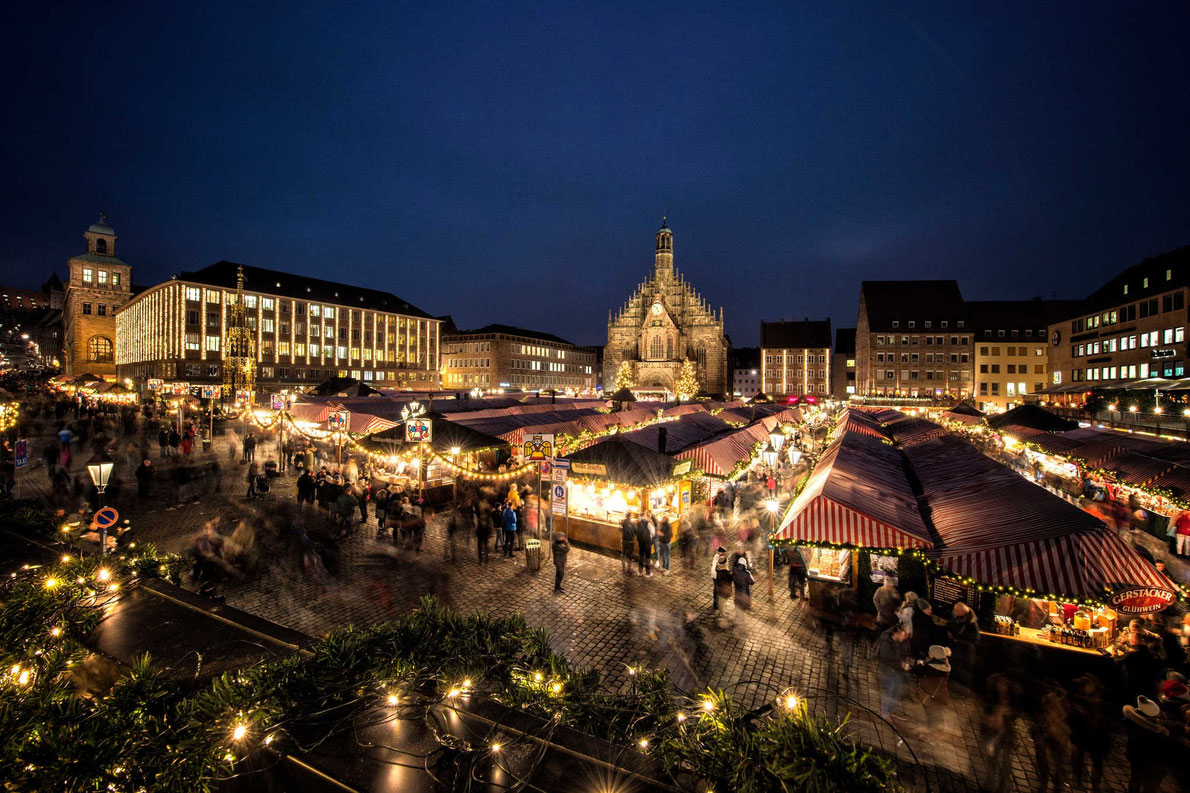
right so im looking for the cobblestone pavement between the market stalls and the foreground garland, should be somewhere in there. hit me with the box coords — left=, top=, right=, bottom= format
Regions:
left=16, top=433, right=1173, bottom=793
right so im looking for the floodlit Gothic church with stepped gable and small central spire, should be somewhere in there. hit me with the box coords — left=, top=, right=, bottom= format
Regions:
left=603, top=218, right=727, bottom=399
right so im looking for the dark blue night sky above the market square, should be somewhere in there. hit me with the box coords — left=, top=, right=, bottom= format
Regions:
left=0, top=0, right=1190, bottom=345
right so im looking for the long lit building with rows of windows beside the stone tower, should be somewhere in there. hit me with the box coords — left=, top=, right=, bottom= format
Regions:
left=115, top=262, right=440, bottom=393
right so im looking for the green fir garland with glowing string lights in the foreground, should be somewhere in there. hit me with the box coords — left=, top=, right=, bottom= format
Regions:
left=0, top=549, right=897, bottom=793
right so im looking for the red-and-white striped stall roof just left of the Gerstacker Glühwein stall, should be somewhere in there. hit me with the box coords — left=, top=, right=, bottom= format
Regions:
left=776, top=432, right=933, bottom=548
